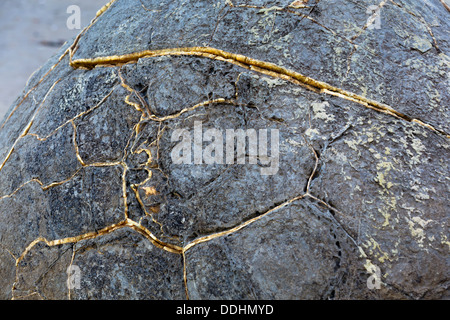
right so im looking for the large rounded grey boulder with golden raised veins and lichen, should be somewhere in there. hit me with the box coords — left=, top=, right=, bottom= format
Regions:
left=0, top=0, right=450, bottom=299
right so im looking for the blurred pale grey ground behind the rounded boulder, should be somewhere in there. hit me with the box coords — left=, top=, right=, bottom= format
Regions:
left=0, top=0, right=108, bottom=122
